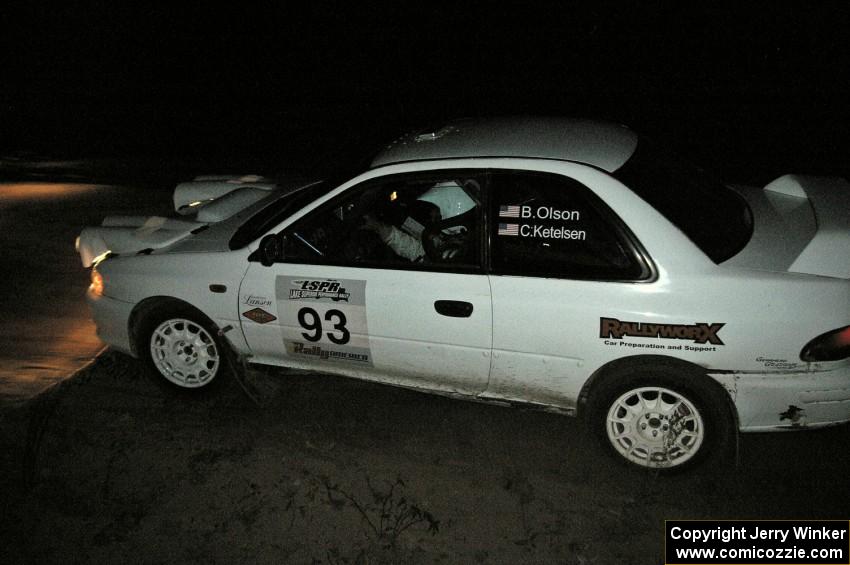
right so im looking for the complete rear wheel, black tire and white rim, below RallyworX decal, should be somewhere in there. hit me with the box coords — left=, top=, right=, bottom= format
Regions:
left=585, top=359, right=737, bottom=473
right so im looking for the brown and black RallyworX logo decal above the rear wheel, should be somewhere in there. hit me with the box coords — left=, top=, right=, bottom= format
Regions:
left=599, top=318, right=726, bottom=351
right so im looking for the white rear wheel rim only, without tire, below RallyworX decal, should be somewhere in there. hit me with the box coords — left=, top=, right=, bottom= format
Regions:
left=605, top=386, right=706, bottom=468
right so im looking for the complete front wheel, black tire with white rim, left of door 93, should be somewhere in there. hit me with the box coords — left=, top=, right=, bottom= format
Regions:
left=136, top=300, right=229, bottom=391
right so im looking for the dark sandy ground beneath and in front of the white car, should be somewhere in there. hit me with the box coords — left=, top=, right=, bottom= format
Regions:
left=0, top=178, right=850, bottom=564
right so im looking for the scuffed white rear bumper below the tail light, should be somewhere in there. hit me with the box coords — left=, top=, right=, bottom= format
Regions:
left=712, top=362, right=850, bottom=432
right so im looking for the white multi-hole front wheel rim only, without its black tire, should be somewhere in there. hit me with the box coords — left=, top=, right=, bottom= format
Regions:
left=150, top=318, right=221, bottom=388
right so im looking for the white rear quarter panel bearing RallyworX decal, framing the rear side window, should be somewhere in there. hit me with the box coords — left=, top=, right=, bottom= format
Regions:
left=487, top=163, right=850, bottom=408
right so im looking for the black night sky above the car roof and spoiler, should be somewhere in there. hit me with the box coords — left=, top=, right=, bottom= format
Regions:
left=0, top=1, right=850, bottom=181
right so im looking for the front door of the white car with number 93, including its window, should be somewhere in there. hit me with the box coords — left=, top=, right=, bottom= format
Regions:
left=239, top=170, right=492, bottom=394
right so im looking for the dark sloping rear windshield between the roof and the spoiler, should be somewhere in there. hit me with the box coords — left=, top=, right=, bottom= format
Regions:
left=614, top=138, right=753, bottom=263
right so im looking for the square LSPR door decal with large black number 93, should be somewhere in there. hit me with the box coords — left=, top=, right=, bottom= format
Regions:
left=275, top=276, right=372, bottom=365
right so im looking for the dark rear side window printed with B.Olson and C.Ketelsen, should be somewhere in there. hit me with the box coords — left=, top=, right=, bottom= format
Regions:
left=490, top=171, right=650, bottom=280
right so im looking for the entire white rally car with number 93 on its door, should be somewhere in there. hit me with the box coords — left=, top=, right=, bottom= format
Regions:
left=79, top=118, right=850, bottom=469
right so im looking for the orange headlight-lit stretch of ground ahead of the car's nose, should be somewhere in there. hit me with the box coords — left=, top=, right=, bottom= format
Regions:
left=0, top=181, right=169, bottom=403
